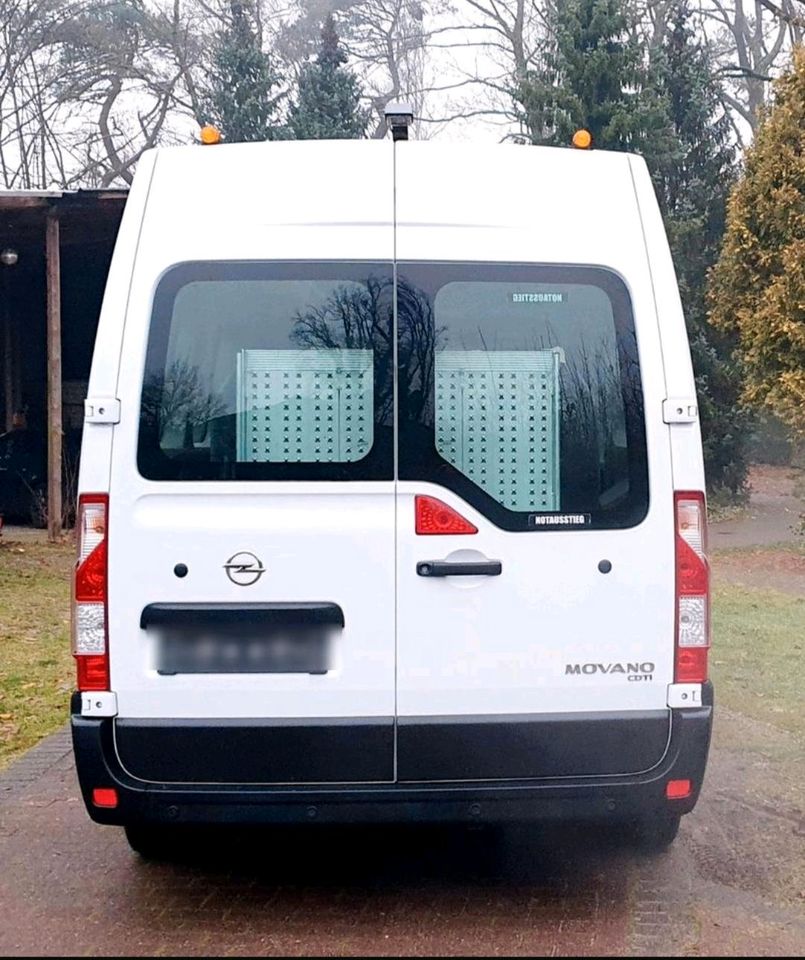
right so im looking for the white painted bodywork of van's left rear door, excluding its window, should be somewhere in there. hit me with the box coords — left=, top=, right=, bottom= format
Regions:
left=109, top=143, right=395, bottom=780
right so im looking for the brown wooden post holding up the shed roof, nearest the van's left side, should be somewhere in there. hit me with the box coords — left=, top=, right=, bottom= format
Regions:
left=45, top=211, right=63, bottom=543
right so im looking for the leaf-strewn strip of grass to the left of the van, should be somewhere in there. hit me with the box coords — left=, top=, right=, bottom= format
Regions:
left=0, top=540, right=75, bottom=769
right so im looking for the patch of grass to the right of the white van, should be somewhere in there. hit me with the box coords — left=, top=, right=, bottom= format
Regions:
left=710, top=584, right=805, bottom=736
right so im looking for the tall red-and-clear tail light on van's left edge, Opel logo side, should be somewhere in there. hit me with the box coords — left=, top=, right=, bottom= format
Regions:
left=73, top=493, right=109, bottom=691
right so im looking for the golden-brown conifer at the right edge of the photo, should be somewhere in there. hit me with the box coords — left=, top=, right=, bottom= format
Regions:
left=711, top=47, right=805, bottom=438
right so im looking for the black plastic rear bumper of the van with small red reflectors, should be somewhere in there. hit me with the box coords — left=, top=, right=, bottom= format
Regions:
left=72, top=684, right=713, bottom=824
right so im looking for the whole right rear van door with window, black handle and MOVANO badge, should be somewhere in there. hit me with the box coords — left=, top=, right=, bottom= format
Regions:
left=396, top=143, right=674, bottom=781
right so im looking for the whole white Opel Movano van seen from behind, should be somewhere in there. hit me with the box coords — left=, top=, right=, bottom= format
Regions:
left=72, top=135, right=712, bottom=851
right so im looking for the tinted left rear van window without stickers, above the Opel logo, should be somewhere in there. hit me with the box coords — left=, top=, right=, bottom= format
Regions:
left=138, top=263, right=393, bottom=480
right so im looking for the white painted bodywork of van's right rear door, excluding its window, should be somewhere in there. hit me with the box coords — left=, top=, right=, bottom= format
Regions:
left=397, top=143, right=674, bottom=779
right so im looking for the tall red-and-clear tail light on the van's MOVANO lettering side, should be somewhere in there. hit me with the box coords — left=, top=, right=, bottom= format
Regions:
left=674, top=492, right=710, bottom=683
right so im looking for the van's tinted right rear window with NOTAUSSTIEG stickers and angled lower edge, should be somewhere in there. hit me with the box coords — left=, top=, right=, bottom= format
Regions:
left=398, top=264, right=648, bottom=530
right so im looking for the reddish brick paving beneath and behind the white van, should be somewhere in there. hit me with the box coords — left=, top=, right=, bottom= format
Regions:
left=0, top=734, right=630, bottom=955
